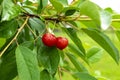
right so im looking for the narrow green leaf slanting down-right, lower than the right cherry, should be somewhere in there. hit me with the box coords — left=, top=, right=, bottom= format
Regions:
left=67, top=53, right=88, bottom=72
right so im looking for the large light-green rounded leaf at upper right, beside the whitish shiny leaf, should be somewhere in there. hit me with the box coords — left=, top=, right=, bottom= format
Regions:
left=79, top=0, right=100, bottom=26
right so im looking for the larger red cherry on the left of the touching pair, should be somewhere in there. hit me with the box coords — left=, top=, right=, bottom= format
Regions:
left=42, top=33, right=57, bottom=47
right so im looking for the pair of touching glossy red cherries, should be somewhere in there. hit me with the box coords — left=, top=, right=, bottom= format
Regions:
left=42, top=33, right=68, bottom=50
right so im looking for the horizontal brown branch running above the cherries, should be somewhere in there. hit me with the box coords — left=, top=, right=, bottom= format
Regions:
left=21, top=13, right=120, bottom=23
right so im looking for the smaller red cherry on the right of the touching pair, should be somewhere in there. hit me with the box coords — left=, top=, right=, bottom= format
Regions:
left=56, top=37, right=68, bottom=50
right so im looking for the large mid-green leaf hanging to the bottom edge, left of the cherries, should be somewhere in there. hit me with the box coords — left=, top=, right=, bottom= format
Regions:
left=15, top=46, right=40, bottom=80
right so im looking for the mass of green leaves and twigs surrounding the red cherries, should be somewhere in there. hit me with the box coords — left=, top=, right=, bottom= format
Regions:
left=0, top=0, right=120, bottom=80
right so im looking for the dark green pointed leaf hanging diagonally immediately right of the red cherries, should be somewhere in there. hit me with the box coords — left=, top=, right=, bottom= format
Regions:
left=62, top=28, right=85, bottom=54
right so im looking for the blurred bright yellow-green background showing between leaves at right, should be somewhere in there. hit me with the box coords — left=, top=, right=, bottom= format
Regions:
left=56, top=30, right=120, bottom=80
